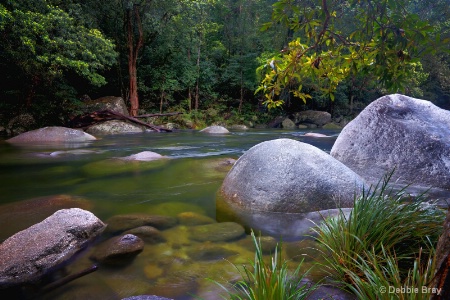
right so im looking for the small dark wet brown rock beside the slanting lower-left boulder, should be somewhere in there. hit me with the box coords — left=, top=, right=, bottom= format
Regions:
left=91, top=234, right=144, bottom=265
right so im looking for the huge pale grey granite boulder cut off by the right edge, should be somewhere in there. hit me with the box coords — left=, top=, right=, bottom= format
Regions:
left=331, top=94, right=450, bottom=190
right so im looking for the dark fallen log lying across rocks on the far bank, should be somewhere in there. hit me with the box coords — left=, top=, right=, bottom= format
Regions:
left=70, top=109, right=172, bottom=132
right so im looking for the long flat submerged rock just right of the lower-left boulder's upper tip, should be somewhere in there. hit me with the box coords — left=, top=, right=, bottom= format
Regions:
left=105, top=214, right=177, bottom=232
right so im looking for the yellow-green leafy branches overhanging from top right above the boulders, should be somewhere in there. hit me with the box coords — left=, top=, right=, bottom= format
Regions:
left=258, top=0, right=439, bottom=107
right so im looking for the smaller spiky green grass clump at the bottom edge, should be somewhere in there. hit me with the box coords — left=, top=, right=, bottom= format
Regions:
left=215, top=232, right=316, bottom=300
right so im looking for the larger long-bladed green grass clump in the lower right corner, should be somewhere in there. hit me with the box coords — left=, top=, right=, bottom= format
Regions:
left=314, top=174, right=445, bottom=299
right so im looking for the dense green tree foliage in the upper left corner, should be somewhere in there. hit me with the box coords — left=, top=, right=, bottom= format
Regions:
left=0, top=1, right=117, bottom=86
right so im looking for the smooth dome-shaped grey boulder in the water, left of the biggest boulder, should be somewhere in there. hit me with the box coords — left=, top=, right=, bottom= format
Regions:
left=219, top=139, right=364, bottom=213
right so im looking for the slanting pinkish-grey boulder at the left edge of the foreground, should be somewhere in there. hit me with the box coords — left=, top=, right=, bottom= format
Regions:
left=0, top=208, right=105, bottom=289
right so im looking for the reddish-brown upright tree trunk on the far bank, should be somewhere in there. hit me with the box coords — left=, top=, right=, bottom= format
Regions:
left=127, top=5, right=143, bottom=116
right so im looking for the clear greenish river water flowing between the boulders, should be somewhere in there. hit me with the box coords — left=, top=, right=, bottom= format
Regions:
left=0, top=130, right=338, bottom=299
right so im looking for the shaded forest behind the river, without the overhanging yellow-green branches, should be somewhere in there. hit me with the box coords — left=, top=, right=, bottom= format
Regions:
left=0, top=0, right=450, bottom=126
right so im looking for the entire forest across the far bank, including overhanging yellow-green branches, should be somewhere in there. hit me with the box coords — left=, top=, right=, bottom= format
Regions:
left=0, top=0, right=450, bottom=127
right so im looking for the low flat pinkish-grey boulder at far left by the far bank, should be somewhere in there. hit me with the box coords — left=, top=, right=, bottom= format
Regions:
left=6, top=126, right=96, bottom=143
